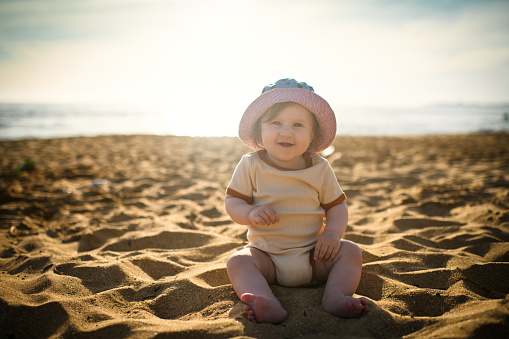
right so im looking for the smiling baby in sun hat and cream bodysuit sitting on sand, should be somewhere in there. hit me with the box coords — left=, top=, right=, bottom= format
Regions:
left=225, top=79, right=368, bottom=324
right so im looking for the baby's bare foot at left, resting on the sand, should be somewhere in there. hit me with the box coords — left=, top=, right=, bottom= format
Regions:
left=240, top=293, right=288, bottom=324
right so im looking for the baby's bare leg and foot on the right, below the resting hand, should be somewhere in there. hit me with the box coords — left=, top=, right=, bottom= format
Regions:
left=316, top=240, right=368, bottom=318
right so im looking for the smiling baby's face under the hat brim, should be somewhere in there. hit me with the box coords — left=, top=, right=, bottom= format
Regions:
left=261, top=104, right=314, bottom=169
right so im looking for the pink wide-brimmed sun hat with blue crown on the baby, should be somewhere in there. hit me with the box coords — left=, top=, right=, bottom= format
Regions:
left=239, top=79, right=336, bottom=153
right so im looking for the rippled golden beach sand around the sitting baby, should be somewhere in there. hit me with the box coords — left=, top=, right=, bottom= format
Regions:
left=0, top=134, right=509, bottom=338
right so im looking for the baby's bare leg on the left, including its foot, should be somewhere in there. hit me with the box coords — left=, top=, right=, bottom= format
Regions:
left=226, top=248, right=288, bottom=324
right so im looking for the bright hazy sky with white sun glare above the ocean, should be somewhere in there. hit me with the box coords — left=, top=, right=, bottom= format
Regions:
left=0, top=0, right=509, bottom=137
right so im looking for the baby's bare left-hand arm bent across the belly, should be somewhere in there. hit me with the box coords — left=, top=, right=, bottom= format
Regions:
left=224, top=194, right=279, bottom=226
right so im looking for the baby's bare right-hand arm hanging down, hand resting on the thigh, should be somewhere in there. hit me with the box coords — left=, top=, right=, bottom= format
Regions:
left=314, top=202, right=348, bottom=261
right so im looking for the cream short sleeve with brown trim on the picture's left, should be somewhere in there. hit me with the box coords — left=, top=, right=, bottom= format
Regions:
left=226, top=154, right=254, bottom=203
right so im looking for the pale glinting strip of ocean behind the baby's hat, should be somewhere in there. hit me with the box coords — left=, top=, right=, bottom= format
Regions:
left=0, top=104, right=509, bottom=140
